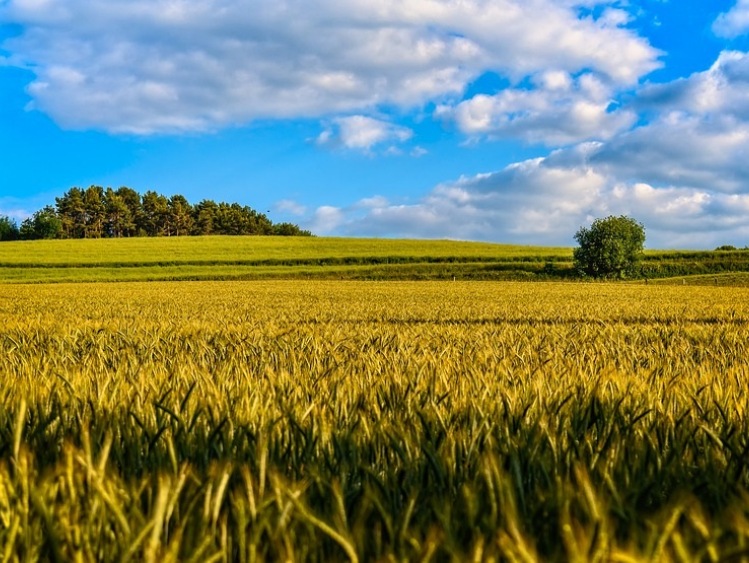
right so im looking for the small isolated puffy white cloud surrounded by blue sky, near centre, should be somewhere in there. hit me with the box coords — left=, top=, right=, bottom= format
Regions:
left=317, top=115, right=413, bottom=152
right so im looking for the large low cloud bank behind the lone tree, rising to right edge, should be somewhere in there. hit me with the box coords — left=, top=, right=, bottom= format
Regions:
left=306, top=46, right=749, bottom=248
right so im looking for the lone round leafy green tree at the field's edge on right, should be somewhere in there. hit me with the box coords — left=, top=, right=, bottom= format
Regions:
left=573, top=215, right=645, bottom=278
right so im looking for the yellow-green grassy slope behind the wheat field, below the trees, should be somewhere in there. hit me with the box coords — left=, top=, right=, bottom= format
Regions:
left=0, top=236, right=749, bottom=285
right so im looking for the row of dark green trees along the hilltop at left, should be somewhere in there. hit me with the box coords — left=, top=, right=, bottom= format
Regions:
left=0, top=186, right=312, bottom=240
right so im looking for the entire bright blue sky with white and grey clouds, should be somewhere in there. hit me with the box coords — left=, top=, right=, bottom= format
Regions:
left=0, top=0, right=749, bottom=249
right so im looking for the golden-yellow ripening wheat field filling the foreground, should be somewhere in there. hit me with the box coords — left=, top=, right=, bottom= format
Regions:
left=0, top=280, right=749, bottom=561
